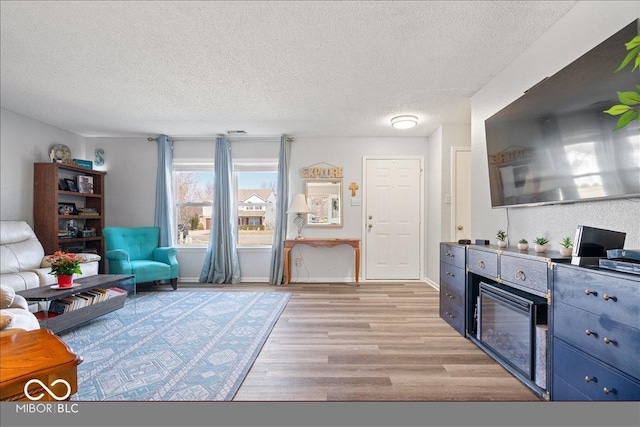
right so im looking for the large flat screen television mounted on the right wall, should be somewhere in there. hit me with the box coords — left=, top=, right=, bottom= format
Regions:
left=485, top=20, right=640, bottom=208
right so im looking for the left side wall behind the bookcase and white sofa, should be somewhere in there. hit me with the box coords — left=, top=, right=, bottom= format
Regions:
left=0, top=108, right=86, bottom=226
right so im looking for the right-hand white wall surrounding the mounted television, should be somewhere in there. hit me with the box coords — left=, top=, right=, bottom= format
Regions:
left=471, top=1, right=640, bottom=250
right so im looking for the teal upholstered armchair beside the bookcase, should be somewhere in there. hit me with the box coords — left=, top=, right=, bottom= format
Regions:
left=102, top=227, right=178, bottom=290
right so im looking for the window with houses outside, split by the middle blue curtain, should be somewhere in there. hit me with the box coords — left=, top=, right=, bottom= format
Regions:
left=173, top=162, right=278, bottom=246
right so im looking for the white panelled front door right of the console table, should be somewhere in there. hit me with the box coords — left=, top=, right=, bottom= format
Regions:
left=365, top=158, right=423, bottom=280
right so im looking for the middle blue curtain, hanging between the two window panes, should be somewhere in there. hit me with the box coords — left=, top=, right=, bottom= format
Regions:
left=200, top=137, right=240, bottom=283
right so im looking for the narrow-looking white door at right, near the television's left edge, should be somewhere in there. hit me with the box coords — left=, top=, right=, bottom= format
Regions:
left=451, top=147, right=471, bottom=242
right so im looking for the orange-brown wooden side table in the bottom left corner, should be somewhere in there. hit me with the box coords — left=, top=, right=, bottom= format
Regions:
left=0, top=329, right=82, bottom=402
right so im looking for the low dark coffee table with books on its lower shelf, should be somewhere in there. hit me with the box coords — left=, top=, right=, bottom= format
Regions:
left=16, top=274, right=136, bottom=333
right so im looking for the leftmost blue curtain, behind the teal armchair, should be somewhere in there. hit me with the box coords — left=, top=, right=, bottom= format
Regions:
left=154, top=135, right=176, bottom=247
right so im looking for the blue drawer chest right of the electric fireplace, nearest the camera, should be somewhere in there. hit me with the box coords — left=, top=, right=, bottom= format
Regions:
left=551, top=264, right=640, bottom=401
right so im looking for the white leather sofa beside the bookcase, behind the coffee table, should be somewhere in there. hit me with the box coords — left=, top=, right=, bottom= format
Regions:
left=0, top=221, right=100, bottom=292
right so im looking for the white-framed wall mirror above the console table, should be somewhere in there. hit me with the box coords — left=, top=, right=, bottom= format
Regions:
left=304, top=179, right=342, bottom=227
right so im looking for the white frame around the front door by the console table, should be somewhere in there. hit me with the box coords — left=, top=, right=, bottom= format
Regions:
left=360, top=155, right=426, bottom=283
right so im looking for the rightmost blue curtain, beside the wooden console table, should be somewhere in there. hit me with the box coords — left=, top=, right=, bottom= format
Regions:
left=269, top=135, right=291, bottom=285
